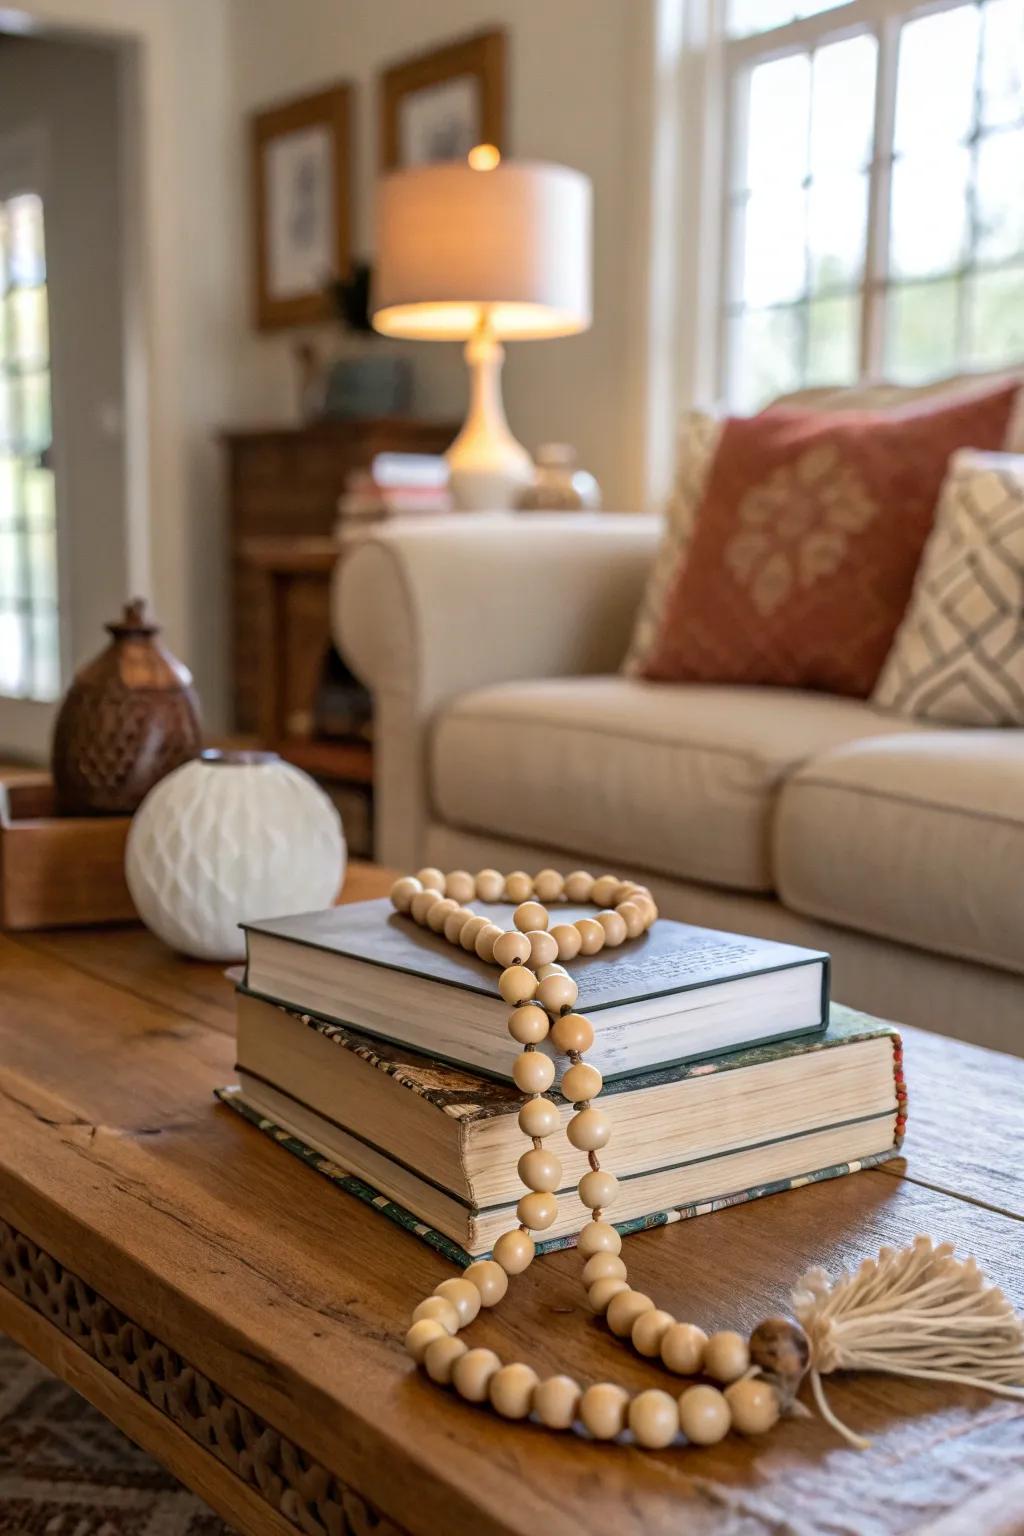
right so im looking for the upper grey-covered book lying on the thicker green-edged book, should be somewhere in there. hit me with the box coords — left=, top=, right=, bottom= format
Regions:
left=246, top=900, right=829, bottom=1081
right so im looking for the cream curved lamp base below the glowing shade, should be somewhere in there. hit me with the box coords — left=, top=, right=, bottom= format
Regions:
left=445, top=315, right=533, bottom=511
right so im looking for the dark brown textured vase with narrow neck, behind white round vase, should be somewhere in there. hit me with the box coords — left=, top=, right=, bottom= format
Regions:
left=52, top=598, right=200, bottom=816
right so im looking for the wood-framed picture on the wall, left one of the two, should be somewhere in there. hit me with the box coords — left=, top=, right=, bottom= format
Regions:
left=252, top=84, right=352, bottom=330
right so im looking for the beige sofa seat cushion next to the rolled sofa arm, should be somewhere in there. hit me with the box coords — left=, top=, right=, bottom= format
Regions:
left=431, top=677, right=906, bottom=891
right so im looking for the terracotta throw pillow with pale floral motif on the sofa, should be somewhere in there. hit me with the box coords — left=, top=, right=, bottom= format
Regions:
left=643, top=382, right=1018, bottom=699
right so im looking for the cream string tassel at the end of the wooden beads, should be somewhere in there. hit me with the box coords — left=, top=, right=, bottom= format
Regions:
left=792, top=1236, right=1024, bottom=1448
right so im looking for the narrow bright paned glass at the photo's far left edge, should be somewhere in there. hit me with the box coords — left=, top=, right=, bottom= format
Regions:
left=0, top=192, right=60, bottom=700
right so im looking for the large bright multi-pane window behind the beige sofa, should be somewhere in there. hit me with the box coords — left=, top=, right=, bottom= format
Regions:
left=720, top=0, right=1024, bottom=410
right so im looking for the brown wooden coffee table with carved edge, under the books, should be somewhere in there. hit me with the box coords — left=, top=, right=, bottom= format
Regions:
left=0, top=866, right=1024, bottom=1536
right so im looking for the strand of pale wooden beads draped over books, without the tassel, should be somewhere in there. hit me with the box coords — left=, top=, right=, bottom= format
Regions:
left=391, top=868, right=809, bottom=1450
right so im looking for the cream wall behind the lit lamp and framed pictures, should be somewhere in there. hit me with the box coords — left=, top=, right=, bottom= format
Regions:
left=230, top=0, right=646, bottom=507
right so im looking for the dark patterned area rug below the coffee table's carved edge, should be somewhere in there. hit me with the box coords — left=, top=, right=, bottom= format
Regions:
left=0, top=1333, right=232, bottom=1536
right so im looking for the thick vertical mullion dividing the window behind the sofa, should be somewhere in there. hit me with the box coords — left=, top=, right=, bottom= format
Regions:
left=860, top=17, right=900, bottom=379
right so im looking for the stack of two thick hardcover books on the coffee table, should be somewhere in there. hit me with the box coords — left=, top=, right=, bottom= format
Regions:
left=220, top=902, right=906, bottom=1260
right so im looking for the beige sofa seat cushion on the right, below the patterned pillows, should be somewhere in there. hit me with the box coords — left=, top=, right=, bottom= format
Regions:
left=775, top=730, right=1024, bottom=971
